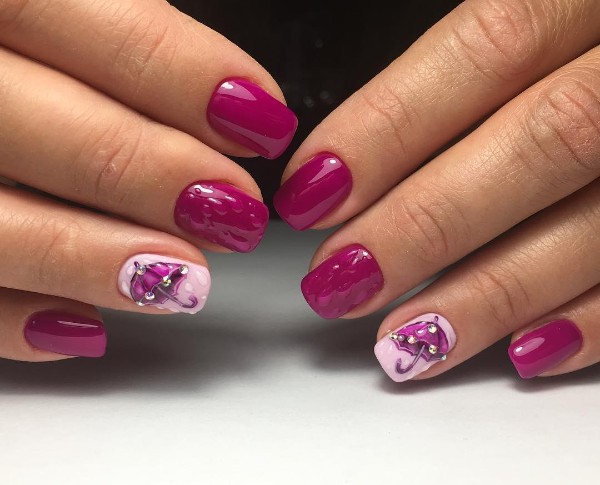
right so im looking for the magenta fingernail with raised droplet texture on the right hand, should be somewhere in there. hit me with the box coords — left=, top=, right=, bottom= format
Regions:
left=301, top=244, right=383, bottom=318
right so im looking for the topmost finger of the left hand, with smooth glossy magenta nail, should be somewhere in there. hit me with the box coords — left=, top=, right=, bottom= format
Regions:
left=0, top=0, right=297, bottom=158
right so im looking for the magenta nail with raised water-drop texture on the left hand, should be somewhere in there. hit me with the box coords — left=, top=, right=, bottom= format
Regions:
left=174, top=182, right=269, bottom=253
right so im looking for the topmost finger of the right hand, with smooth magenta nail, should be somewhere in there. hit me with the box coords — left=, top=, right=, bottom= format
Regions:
left=275, top=0, right=600, bottom=229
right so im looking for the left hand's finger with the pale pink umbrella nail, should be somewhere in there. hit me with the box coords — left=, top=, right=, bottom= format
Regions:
left=0, top=187, right=210, bottom=313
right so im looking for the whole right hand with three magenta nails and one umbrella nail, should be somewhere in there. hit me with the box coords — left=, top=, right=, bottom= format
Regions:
left=275, top=0, right=600, bottom=381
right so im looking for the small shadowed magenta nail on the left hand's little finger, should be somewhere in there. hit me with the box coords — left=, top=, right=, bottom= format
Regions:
left=24, top=311, right=106, bottom=357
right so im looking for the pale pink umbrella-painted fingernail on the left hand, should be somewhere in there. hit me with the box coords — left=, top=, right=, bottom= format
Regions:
left=118, top=254, right=210, bottom=314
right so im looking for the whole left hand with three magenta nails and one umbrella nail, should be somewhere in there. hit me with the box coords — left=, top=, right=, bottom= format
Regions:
left=0, top=0, right=296, bottom=361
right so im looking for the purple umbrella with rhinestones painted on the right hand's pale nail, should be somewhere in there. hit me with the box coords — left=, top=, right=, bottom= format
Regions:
left=389, top=316, right=449, bottom=374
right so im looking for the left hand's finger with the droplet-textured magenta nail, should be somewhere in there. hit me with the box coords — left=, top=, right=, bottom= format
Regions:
left=0, top=48, right=269, bottom=252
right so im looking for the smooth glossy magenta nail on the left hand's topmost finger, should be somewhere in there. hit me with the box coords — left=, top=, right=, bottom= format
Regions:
left=208, top=79, right=298, bottom=159
